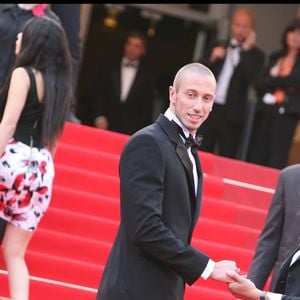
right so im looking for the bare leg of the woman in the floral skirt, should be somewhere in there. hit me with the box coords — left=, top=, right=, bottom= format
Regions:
left=2, top=223, right=33, bottom=300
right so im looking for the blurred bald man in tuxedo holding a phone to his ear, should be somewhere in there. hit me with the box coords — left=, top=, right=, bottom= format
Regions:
left=199, top=9, right=264, bottom=158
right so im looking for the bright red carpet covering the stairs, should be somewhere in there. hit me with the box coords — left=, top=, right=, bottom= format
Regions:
left=0, top=123, right=279, bottom=300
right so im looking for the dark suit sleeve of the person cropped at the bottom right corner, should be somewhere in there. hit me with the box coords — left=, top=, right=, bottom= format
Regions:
left=274, top=248, right=300, bottom=300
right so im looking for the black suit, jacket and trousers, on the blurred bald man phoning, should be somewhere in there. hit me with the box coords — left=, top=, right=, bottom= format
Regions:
left=199, top=45, right=264, bottom=158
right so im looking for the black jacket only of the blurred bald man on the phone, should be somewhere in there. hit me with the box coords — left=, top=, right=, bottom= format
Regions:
left=205, top=44, right=265, bottom=125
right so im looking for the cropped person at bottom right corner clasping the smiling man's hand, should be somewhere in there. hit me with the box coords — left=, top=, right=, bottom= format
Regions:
left=227, top=247, right=300, bottom=300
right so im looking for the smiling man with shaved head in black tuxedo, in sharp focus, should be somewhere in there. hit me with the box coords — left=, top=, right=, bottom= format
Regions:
left=97, top=63, right=238, bottom=300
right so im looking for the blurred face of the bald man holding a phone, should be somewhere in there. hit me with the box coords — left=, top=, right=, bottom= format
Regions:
left=231, top=12, right=253, bottom=43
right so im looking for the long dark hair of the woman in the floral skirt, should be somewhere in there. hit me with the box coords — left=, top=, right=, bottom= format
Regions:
left=3, top=16, right=73, bottom=149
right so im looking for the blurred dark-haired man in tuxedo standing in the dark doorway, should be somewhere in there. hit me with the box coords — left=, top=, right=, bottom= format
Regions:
left=91, top=31, right=156, bottom=134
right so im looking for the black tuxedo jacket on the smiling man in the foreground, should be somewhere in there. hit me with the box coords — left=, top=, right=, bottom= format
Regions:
left=97, top=115, right=209, bottom=300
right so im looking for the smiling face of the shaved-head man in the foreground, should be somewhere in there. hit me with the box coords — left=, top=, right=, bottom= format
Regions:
left=169, top=72, right=216, bottom=133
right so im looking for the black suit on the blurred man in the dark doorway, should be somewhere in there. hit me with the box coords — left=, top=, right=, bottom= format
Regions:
left=91, top=61, right=156, bottom=134
